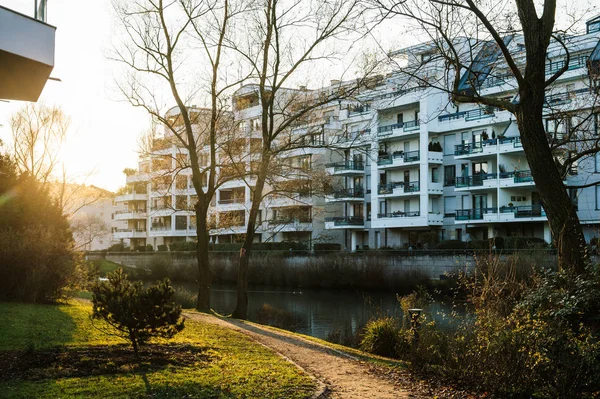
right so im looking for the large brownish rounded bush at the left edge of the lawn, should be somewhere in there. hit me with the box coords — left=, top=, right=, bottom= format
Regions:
left=0, top=155, right=78, bottom=302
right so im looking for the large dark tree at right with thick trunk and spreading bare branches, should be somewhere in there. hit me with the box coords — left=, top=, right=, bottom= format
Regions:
left=372, top=0, right=596, bottom=273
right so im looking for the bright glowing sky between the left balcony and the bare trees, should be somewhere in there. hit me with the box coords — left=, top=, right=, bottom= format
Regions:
left=0, top=0, right=149, bottom=191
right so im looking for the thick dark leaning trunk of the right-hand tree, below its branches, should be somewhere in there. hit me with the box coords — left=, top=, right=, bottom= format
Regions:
left=516, top=97, right=586, bottom=274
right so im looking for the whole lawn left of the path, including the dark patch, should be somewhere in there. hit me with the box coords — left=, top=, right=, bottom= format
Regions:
left=0, top=300, right=314, bottom=399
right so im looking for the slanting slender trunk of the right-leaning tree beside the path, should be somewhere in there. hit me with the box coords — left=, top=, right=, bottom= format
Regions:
left=231, top=161, right=270, bottom=320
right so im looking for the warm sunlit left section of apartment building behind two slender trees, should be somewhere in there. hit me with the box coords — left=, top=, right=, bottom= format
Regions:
left=114, top=95, right=341, bottom=249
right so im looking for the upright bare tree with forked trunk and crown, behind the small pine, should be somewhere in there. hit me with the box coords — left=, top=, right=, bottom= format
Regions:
left=113, top=0, right=245, bottom=311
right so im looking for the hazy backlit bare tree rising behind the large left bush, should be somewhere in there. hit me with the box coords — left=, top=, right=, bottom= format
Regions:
left=10, top=103, right=71, bottom=183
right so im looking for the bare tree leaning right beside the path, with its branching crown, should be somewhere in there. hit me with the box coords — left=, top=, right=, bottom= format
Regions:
left=227, top=0, right=378, bottom=319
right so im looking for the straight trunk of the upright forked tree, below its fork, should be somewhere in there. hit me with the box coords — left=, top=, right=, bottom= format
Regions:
left=196, top=205, right=212, bottom=312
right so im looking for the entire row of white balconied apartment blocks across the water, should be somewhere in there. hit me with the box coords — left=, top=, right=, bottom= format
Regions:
left=115, top=18, right=600, bottom=250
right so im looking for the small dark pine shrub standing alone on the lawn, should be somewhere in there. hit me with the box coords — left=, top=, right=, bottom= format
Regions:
left=92, top=269, right=184, bottom=353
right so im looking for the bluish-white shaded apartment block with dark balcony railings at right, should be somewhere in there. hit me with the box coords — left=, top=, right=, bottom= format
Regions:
left=327, top=18, right=600, bottom=250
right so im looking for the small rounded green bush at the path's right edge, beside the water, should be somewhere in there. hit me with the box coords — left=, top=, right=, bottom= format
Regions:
left=360, top=317, right=400, bottom=357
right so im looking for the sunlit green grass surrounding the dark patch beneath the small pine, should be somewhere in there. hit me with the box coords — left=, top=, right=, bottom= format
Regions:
left=0, top=300, right=314, bottom=399
